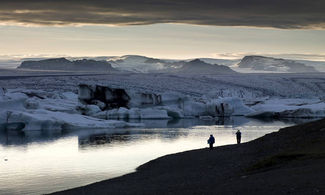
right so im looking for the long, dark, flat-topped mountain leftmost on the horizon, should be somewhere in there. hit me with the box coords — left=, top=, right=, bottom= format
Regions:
left=18, top=58, right=116, bottom=72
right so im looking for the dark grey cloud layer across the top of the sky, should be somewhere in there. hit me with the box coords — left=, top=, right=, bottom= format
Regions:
left=0, top=0, right=325, bottom=29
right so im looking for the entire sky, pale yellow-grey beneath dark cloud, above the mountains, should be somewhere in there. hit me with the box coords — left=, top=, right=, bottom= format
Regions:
left=0, top=0, right=325, bottom=60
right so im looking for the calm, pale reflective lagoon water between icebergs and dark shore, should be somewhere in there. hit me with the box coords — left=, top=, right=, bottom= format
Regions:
left=0, top=117, right=312, bottom=194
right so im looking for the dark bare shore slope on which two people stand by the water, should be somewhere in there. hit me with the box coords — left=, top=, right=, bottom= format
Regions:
left=50, top=119, right=325, bottom=194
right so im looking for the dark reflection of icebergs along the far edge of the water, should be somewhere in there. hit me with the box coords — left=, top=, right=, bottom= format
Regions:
left=0, top=117, right=307, bottom=145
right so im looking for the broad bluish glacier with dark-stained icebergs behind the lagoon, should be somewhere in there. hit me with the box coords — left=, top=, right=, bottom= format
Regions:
left=0, top=72, right=325, bottom=131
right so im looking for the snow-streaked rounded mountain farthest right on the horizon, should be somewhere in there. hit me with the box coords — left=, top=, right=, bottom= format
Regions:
left=238, top=56, right=317, bottom=73
